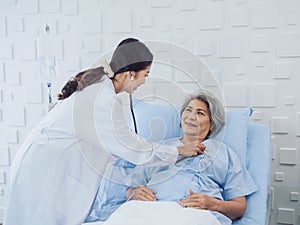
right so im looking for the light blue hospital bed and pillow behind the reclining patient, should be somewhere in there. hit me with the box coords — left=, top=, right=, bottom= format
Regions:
left=82, top=101, right=271, bottom=225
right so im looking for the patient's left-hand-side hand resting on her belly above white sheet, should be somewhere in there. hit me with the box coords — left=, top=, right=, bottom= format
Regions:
left=126, top=185, right=156, bottom=201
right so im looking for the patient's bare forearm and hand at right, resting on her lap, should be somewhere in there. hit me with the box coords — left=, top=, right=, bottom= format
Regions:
left=179, top=190, right=246, bottom=220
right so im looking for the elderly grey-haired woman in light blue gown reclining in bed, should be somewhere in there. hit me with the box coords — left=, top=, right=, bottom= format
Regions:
left=87, top=92, right=256, bottom=225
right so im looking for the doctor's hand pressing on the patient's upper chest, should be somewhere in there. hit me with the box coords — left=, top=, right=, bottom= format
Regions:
left=177, top=140, right=206, bottom=157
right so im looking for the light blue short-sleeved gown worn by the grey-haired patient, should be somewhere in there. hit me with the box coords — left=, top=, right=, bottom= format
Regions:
left=86, top=138, right=257, bottom=225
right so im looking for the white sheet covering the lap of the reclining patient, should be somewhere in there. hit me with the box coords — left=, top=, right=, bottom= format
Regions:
left=103, top=201, right=220, bottom=225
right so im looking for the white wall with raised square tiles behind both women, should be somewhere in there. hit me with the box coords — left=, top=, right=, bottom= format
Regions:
left=0, top=0, right=300, bottom=225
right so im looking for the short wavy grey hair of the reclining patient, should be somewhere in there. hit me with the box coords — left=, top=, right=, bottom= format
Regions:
left=180, top=90, right=225, bottom=137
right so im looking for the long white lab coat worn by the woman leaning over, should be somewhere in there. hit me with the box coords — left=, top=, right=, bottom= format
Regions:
left=4, top=78, right=178, bottom=225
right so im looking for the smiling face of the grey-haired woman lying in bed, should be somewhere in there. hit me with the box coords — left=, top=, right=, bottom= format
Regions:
left=181, top=99, right=211, bottom=140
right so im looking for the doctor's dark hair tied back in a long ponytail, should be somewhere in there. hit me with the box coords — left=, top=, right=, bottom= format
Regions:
left=58, top=38, right=153, bottom=100
